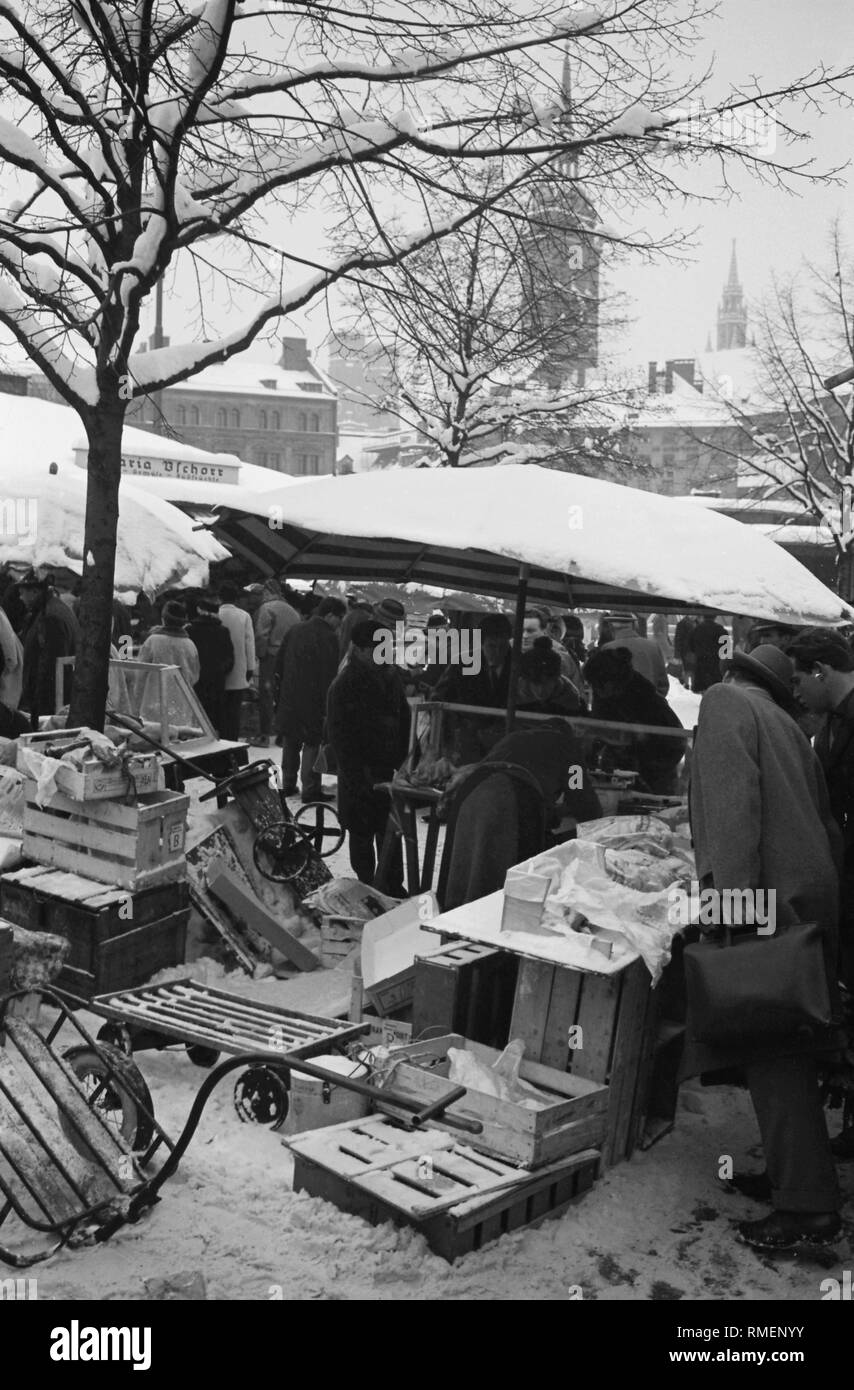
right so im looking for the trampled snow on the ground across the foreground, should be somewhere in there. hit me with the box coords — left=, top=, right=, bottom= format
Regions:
left=21, top=1052, right=854, bottom=1301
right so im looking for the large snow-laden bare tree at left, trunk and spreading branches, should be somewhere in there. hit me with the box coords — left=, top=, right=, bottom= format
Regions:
left=0, top=0, right=846, bottom=727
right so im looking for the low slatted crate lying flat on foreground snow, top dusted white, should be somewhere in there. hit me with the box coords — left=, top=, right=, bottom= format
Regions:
left=285, top=1115, right=599, bottom=1262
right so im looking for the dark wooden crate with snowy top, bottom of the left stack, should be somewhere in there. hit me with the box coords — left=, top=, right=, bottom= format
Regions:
left=0, top=865, right=189, bottom=999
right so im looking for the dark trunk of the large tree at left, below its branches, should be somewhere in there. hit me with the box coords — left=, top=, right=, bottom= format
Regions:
left=68, top=396, right=127, bottom=731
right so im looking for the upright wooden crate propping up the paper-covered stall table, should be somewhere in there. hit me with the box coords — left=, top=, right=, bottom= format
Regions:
left=509, top=956, right=654, bottom=1166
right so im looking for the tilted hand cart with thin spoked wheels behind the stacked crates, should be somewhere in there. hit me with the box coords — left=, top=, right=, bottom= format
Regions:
left=107, top=710, right=344, bottom=883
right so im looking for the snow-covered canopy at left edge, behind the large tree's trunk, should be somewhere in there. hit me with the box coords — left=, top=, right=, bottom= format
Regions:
left=0, top=395, right=229, bottom=592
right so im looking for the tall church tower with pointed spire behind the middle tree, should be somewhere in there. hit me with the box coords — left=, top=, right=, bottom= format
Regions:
left=523, top=53, right=599, bottom=388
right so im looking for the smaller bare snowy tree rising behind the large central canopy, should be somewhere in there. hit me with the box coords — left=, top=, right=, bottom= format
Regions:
left=332, top=189, right=645, bottom=475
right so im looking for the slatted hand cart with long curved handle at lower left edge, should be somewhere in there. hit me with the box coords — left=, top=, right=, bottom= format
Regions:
left=0, top=990, right=481, bottom=1269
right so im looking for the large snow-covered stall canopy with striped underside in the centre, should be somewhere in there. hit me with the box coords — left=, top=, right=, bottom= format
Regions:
left=216, top=464, right=854, bottom=623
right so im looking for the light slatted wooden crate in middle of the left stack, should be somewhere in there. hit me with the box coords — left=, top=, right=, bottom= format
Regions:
left=24, top=780, right=189, bottom=890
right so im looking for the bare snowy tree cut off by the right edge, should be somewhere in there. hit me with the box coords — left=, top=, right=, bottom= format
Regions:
left=692, top=224, right=854, bottom=602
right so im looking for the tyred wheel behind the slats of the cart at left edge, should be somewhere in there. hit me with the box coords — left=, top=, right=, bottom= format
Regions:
left=60, top=1043, right=154, bottom=1154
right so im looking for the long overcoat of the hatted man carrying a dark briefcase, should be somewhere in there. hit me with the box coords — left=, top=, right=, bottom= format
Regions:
left=682, top=684, right=839, bottom=1076
